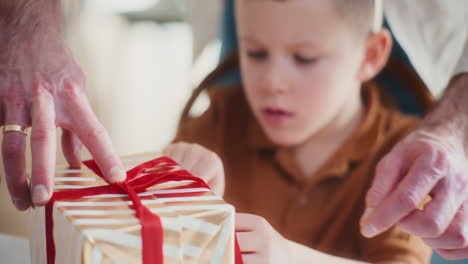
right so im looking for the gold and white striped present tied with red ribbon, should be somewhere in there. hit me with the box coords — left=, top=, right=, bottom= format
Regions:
left=30, top=155, right=242, bottom=264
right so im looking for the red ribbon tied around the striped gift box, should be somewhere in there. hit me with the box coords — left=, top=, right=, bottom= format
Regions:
left=45, top=157, right=243, bottom=264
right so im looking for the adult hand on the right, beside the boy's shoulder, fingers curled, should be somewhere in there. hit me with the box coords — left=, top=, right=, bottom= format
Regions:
left=361, top=75, right=468, bottom=259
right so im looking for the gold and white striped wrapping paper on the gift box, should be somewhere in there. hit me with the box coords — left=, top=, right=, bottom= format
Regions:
left=30, top=154, right=235, bottom=264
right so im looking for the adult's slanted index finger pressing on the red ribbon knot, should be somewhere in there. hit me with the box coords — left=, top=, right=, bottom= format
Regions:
left=63, top=82, right=126, bottom=182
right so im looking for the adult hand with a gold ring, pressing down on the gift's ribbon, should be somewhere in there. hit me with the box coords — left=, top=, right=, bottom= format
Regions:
left=0, top=0, right=125, bottom=210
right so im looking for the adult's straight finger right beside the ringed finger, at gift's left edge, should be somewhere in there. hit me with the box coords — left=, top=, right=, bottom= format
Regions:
left=31, top=84, right=56, bottom=206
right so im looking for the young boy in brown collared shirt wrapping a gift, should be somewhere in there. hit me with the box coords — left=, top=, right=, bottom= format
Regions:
left=164, top=0, right=430, bottom=264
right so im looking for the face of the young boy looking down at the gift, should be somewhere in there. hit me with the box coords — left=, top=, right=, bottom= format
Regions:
left=236, top=0, right=372, bottom=146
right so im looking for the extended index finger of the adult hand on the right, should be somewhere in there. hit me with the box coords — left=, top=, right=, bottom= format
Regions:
left=362, top=154, right=445, bottom=237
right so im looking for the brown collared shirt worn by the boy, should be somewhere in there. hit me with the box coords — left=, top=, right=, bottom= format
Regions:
left=175, top=85, right=431, bottom=264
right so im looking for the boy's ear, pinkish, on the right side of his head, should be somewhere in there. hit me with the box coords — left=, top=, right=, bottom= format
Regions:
left=358, top=29, right=393, bottom=82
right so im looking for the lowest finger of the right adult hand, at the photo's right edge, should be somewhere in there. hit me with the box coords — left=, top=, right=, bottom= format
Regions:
left=424, top=201, right=468, bottom=250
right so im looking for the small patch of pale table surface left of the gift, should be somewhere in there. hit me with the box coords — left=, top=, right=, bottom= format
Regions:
left=0, top=234, right=30, bottom=264
